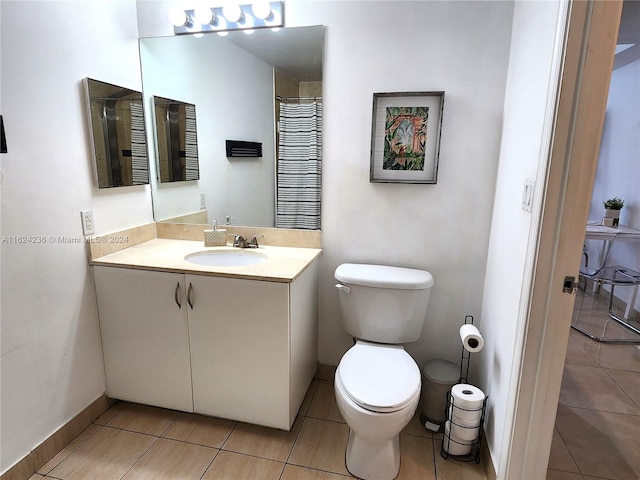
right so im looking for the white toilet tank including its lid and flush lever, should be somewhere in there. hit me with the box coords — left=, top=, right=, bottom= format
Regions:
left=334, top=263, right=433, bottom=343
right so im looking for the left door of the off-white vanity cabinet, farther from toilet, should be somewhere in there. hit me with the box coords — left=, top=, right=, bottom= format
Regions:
left=93, top=266, right=193, bottom=412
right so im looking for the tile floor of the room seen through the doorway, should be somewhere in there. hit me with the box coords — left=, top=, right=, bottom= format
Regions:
left=547, top=290, right=640, bottom=480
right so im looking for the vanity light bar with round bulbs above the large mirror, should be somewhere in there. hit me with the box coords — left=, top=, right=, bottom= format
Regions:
left=169, top=0, right=284, bottom=35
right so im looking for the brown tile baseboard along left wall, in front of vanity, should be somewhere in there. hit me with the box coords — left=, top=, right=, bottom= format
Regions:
left=0, top=394, right=114, bottom=480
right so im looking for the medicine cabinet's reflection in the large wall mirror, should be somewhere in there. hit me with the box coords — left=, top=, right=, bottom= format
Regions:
left=153, top=96, right=200, bottom=182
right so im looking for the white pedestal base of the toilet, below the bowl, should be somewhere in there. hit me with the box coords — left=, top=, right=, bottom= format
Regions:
left=346, top=429, right=400, bottom=480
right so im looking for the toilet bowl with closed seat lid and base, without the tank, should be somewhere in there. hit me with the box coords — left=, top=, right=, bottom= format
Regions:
left=334, top=341, right=421, bottom=480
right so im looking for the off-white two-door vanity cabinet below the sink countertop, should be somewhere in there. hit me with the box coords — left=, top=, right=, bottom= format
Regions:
left=94, top=261, right=318, bottom=430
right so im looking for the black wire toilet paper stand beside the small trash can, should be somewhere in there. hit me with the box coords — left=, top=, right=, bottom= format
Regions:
left=440, top=315, right=489, bottom=464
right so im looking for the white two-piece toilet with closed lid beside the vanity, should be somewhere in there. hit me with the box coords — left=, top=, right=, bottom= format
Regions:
left=335, top=263, right=433, bottom=480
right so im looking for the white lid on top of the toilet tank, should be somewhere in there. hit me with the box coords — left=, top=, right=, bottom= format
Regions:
left=334, top=263, right=433, bottom=290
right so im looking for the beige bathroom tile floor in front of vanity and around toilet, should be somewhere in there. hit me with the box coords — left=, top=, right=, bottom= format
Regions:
left=30, top=380, right=486, bottom=480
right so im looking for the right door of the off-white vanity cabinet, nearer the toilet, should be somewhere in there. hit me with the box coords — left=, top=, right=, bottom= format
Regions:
left=186, top=275, right=291, bottom=430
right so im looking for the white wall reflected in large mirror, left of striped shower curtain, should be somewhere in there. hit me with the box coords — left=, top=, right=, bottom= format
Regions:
left=140, top=35, right=275, bottom=227
